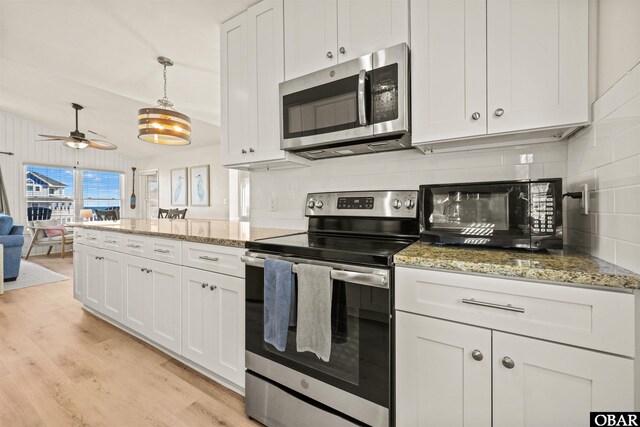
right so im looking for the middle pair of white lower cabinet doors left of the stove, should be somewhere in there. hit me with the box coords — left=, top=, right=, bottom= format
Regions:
left=123, top=255, right=181, bottom=353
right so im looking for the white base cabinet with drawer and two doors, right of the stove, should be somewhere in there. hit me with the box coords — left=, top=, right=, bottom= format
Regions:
left=396, top=267, right=637, bottom=426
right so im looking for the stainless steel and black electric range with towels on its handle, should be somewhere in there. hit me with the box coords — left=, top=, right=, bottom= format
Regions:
left=242, top=191, right=419, bottom=426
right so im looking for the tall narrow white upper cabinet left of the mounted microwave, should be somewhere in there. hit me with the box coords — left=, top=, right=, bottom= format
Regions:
left=220, top=0, right=307, bottom=169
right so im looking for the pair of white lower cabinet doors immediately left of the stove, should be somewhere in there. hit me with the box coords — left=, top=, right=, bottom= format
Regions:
left=182, top=267, right=245, bottom=387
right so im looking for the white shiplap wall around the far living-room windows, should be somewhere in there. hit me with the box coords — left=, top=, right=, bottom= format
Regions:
left=0, top=111, right=137, bottom=254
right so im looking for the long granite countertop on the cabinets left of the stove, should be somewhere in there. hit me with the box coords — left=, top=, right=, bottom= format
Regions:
left=65, top=219, right=300, bottom=248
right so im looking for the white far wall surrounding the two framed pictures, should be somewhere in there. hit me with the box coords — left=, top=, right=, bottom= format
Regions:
left=138, top=145, right=229, bottom=219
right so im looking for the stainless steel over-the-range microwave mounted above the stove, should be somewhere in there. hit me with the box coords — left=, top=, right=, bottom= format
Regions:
left=280, top=43, right=411, bottom=160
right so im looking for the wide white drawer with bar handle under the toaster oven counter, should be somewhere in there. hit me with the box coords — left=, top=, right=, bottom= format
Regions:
left=395, top=267, right=635, bottom=357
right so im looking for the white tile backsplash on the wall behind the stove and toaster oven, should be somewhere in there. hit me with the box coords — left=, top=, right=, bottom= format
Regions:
left=251, top=142, right=567, bottom=230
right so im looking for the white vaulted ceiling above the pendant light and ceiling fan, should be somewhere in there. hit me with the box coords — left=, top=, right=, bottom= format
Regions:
left=0, top=0, right=255, bottom=158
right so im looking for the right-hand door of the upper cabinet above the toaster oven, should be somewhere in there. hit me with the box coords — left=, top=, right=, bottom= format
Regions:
left=487, top=0, right=589, bottom=133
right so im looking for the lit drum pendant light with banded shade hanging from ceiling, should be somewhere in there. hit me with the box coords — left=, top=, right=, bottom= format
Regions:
left=138, top=56, right=191, bottom=145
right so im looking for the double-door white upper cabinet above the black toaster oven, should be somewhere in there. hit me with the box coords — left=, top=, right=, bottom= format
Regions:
left=411, top=0, right=589, bottom=149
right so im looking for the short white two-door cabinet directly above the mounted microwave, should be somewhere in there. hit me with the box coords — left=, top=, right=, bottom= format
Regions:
left=284, top=0, right=409, bottom=80
